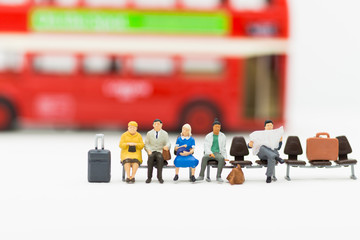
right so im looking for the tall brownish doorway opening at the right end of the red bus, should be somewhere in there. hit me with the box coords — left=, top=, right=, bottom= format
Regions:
left=245, top=56, right=280, bottom=119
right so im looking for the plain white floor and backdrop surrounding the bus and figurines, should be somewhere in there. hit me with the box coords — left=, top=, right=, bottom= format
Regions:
left=0, top=0, right=360, bottom=240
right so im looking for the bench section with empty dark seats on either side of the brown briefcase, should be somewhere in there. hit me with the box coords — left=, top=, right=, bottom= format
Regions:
left=284, top=136, right=357, bottom=181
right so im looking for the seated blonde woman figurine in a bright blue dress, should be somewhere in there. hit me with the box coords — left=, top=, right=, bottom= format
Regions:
left=174, top=124, right=199, bottom=182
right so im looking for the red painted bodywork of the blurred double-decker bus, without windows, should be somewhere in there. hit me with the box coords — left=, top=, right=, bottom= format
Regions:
left=0, top=0, right=288, bottom=133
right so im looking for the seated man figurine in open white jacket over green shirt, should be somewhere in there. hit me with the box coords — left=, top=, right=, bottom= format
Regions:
left=197, top=119, right=229, bottom=182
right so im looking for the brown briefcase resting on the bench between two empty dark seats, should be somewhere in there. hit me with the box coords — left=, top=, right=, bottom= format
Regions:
left=306, top=132, right=339, bottom=161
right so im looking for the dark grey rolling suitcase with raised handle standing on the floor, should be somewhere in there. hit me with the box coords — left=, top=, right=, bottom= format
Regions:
left=88, top=134, right=111, bottom=182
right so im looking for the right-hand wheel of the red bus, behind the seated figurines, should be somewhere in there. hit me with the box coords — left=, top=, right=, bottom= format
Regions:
left=180, top=103, right=220, bottom=134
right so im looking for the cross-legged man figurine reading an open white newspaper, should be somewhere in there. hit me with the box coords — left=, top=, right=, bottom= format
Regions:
left=248, top=120, right=284, bottom=183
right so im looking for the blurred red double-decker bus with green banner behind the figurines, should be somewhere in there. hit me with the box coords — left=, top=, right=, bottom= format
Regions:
left=0, top=0, right=288, bottom=133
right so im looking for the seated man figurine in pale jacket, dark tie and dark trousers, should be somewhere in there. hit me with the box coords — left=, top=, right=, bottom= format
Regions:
left=145, top=119, right=171, bottom=183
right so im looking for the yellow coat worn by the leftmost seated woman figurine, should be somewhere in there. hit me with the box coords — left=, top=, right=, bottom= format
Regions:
left=119, top=131, right=144, bottom=163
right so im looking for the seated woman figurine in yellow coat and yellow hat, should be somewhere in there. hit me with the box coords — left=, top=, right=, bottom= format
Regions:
left=119, top=121, right=144, bottom=183
